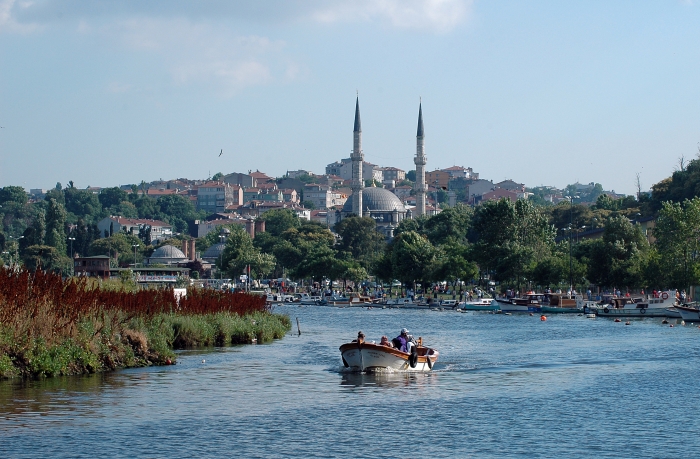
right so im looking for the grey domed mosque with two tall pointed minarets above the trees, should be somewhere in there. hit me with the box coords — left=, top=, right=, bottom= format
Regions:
left=336, top=97, right=427, bottom=239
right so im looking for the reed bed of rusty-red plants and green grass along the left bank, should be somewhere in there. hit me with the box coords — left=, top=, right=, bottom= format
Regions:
left=0, top=269, right=291, bottom=377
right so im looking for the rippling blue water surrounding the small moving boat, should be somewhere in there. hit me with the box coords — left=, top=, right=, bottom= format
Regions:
left=0, top=307, right=700, bottom=458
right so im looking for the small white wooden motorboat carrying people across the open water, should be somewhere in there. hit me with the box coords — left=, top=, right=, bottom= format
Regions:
left=340, top=338, right=439, bottom=372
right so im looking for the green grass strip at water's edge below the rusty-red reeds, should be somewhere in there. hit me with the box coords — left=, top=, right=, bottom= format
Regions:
left=0, top=312, right=291, bottom=378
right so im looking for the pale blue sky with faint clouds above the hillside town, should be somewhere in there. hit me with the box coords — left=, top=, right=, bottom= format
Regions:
left=0, top=0, right=700, bottom=194
